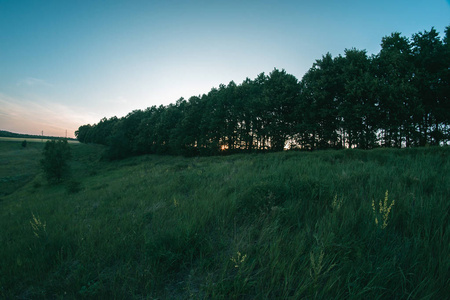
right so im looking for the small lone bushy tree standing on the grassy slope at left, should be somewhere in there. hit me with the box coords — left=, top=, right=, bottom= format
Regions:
left=41, top=140, right=71, bottom=182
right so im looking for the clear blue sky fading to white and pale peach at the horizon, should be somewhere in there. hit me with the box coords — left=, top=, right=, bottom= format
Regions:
left=0, top=0, right=450, bottom=137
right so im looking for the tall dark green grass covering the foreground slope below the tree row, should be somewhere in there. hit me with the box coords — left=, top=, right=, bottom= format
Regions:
left=0, top=145, right=450, bottom=299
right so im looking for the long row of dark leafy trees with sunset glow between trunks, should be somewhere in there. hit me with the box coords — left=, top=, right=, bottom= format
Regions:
left=75, top=26, right=450, bottom=159
